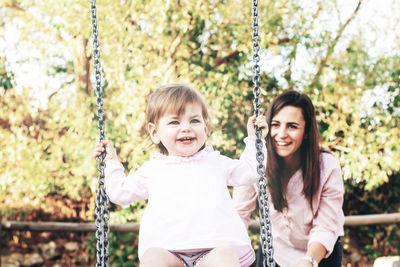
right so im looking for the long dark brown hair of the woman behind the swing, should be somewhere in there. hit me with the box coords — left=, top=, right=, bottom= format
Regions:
left=266, top=91, right=321, bottom=212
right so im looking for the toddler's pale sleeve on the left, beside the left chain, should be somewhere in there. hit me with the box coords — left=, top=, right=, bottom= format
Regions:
left=104, top=160, right=148, bottom=206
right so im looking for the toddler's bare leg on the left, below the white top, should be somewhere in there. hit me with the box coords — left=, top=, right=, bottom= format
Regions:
left=139, top=248, right=185, bottom=267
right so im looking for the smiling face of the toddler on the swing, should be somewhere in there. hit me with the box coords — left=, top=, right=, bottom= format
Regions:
left=148, top=103, right=207, bottom=157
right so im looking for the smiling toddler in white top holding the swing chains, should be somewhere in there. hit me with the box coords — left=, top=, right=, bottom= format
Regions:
left=93, top=84, right=268, bottom=267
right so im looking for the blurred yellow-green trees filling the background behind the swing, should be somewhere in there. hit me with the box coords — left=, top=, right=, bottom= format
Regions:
left=0, top=0, right=400, bottom=264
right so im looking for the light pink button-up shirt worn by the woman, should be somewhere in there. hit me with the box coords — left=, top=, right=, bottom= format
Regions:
left=233, top=153, right=344, bottom=267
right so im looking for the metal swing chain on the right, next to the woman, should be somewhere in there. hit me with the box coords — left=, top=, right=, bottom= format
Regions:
left=252, top=0, right=275, bottom=267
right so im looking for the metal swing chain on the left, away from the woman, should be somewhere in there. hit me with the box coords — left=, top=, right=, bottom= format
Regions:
left=91, top=0, right=110, bottom=267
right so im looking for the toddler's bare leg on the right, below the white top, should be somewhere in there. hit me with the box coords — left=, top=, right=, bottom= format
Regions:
left=198, top=247, right=240, bottom=267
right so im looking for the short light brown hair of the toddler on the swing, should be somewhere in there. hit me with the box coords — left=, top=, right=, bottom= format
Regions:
left=146, top=83, right=209, bottom=154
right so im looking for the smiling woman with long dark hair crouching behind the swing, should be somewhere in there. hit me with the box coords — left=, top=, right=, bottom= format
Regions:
left=233, top=91, right=344, bottom=267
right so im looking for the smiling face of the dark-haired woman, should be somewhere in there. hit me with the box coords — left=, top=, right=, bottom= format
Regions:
left=270, top=106, right=306, bottom=162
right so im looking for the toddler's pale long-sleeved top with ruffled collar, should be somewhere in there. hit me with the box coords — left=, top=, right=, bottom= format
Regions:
left=105, top=138, right=264, bottom=266
